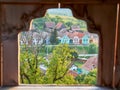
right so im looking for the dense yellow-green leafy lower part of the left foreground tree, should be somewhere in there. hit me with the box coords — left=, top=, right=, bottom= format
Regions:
left=20, top=47, right=44, bottom=84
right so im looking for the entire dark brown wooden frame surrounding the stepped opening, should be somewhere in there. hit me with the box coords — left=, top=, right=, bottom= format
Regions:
left=0, top=0, right=120, bottom=87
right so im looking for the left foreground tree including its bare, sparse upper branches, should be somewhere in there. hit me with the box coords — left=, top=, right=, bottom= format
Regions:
left=20, top=31, right=45, bottom=84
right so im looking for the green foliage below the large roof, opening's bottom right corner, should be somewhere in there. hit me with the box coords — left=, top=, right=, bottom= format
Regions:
left=75, top=69, right=97, bottom=85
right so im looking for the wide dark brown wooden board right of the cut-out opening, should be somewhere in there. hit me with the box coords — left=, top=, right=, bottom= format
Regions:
left=88, top=4, right=116, bottom=87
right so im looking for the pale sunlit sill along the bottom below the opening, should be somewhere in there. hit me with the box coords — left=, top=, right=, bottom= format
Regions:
left=0, top=85, right=113, bottom=90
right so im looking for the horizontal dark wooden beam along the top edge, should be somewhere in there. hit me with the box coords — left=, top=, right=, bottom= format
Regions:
left=0, top=0, right=106, bottom=4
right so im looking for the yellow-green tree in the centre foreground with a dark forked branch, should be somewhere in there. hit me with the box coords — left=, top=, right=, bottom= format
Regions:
left=44, top=44, right=76, bottom=84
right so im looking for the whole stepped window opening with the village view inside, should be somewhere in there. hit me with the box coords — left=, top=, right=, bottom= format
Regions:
left=20, top=8, right=99, bottom=85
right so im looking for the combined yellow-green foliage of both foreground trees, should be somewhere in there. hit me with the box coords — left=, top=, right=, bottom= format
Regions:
left=20, top=44, right=77, bottom=84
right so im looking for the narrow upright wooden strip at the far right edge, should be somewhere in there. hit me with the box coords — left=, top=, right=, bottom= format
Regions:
left=113, top=4, right=120, bottom=88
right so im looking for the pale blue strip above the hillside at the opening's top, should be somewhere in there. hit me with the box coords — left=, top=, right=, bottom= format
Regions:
left=46, top=8, right=73, bottom=17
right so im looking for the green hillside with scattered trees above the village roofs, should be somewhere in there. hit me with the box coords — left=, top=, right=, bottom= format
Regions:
left=33, top=13, right=87, bottom=31
